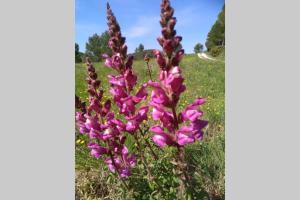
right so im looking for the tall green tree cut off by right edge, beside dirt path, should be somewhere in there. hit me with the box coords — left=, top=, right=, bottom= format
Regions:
left=205, top=5, right=225, bottom=51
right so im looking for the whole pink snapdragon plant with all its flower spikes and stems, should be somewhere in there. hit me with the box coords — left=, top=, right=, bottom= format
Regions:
left=75, top=0, right=208, bottom=198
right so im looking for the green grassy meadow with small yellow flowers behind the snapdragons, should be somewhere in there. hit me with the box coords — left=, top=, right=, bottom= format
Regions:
left=75, top=55, right=225, bottom=200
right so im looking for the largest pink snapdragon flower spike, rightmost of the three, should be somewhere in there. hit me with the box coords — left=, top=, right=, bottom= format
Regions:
left=148, top=0, right=207, bottom=147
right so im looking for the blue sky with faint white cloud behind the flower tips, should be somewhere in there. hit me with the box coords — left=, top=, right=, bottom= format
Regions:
left=75, top=0, right=224, bottom=53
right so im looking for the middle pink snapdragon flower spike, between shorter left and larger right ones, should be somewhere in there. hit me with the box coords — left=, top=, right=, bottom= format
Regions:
left=103, top=4, right=148, bottom=134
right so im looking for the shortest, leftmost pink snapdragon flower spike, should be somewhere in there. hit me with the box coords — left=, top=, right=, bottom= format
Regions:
left=76, top=59, right=136, bottom=177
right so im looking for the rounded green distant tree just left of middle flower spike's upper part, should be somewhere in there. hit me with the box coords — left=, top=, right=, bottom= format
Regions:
left=85, top=31, right=111, bottom=62
